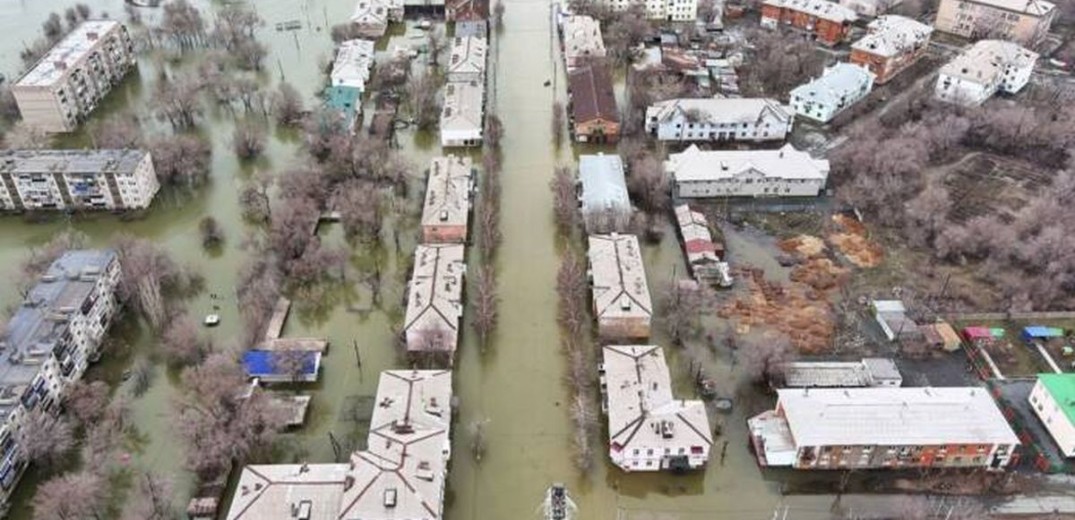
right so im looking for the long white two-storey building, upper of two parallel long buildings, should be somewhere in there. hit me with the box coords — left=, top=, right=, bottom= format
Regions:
left=646, top=98, right=794, bottom=142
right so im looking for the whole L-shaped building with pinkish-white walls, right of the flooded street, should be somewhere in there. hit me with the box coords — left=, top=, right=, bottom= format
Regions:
left=599, top=345, right=713, bottom=472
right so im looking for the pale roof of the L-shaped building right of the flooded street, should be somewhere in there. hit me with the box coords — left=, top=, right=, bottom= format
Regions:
left=603, top=345, right=713, bottom=453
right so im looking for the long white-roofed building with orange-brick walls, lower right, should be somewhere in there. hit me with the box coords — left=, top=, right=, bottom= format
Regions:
left=748, top=387, right=1019, bottom=471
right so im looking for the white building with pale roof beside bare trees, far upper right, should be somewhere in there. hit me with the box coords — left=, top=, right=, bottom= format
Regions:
left=934, top=40, right=1037, bottom=106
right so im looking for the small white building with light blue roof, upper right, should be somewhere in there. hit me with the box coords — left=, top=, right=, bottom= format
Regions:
left=791, top=62, right=874, bottom=122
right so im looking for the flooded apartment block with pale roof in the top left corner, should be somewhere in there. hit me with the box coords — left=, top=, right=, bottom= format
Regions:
left=11, top=20, right=134, bottom=132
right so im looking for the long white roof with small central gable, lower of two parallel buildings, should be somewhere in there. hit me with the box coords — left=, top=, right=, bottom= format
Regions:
left=664, top=144, right=829, bottom=183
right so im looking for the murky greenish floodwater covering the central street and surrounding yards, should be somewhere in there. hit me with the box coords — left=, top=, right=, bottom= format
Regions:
left=0, top=0, right=832, bottom=520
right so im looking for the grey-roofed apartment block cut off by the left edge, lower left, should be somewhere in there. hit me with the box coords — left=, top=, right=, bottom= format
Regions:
left=0, top=250, right=120, bottom=506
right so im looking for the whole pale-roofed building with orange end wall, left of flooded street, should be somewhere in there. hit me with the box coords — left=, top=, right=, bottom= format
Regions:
left=421, top=155, right=474, bottom=244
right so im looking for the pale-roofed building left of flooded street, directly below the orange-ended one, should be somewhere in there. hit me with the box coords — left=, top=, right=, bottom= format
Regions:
left=403, top=244, right=467, bottom=350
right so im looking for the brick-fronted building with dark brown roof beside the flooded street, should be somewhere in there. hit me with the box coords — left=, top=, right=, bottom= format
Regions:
left=568, top=63, right=619, bottom=143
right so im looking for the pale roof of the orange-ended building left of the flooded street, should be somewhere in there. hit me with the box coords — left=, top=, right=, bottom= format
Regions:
left=421, top=155, right=472, bottom=227
